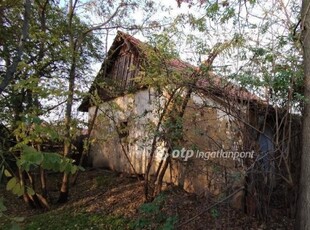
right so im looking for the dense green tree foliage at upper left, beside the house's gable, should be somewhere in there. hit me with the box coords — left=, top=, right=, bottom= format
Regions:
left=0, top=1, right=103, bottom=128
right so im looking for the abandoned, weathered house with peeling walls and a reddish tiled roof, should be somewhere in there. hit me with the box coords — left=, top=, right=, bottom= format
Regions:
left=79, top=32, right=292, bottom=208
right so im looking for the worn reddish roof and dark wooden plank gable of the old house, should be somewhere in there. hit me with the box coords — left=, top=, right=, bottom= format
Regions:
left=78, top=31, right=265, bottom=112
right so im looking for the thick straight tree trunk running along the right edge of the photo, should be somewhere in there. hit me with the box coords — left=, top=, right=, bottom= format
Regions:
left=296, top=0, right=310, bottom=230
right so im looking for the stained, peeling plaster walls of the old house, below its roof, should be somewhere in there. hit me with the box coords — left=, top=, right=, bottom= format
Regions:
left=89, top=90, right=247, bottom=199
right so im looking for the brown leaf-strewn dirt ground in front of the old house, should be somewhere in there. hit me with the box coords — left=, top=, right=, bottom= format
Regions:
left=0, top=169, right=294, bottom=230
